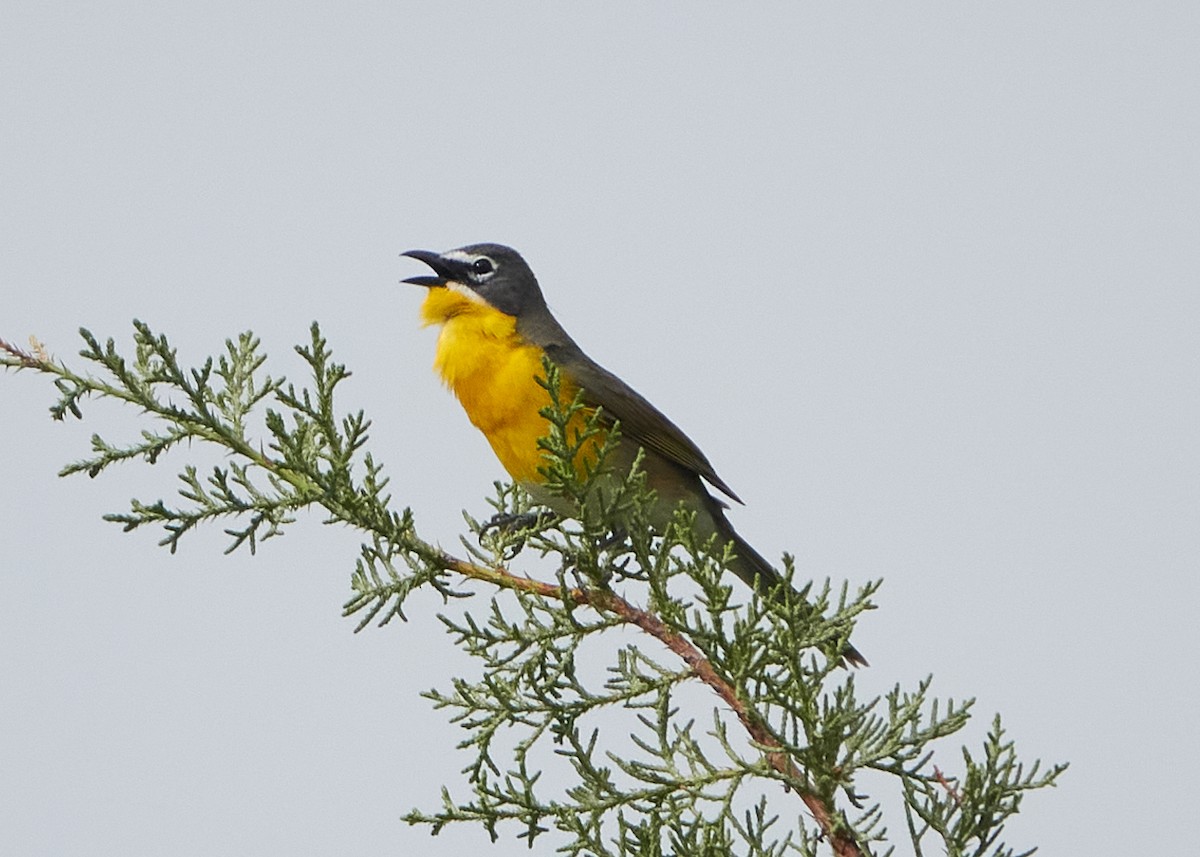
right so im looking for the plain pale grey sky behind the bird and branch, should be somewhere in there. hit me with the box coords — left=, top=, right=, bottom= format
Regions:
left=0, top=0, right=1200, bottom=857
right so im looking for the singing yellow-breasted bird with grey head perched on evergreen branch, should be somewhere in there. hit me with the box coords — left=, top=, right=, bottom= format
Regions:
left=403, top=244, right=866, bottom=665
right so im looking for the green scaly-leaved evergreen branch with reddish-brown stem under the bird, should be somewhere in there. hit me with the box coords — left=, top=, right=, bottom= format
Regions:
left=0, top=322, right=1066, bottom=857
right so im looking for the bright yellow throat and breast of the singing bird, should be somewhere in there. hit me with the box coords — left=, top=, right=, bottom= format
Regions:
left=421, top=286, right=597, bottom=485
